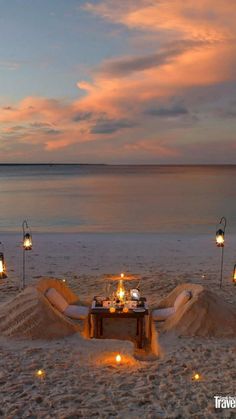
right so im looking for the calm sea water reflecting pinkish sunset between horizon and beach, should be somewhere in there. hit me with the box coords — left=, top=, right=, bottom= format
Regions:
left=0, top=165, right=236, bottom=233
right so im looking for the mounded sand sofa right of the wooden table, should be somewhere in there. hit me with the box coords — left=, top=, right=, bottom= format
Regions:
left=151, top=283, right=236, bottom=355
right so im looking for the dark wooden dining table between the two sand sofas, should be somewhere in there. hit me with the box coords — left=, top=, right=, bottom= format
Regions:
left=90, top=307, right=148, bottom=348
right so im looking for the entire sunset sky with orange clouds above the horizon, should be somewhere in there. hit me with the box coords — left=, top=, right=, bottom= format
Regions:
left=0, top=0, right=236, bottom=164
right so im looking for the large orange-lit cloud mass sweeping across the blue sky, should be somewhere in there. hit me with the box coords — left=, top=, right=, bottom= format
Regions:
left=0, top=0, right=236, bottom=162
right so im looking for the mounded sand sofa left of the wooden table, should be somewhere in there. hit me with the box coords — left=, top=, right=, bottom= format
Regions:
left=0, top=277, right=89, bottom=340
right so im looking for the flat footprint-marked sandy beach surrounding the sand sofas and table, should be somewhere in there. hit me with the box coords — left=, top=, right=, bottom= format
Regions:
left=0, top=234, right=236, bottom=419
